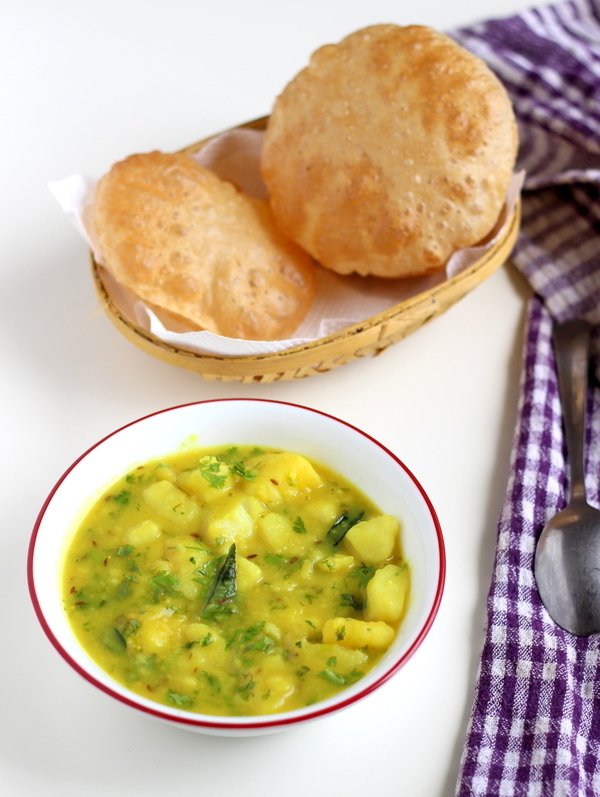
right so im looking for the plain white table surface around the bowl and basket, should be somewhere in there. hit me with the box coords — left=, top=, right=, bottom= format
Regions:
left=0, top=0, right=530, bottom=797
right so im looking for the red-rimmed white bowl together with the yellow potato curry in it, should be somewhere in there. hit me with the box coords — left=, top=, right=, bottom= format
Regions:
left=28, top=399, right=445, bottom=735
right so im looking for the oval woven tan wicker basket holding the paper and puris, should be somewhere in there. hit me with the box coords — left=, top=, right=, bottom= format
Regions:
left=91, top=117, right=520, bottom=382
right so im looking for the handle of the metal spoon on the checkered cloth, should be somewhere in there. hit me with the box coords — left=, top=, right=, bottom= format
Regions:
left=552, top=319, right=592, bottom=501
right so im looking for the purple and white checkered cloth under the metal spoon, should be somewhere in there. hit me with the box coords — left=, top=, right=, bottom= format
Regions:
left=453, top=0, right=600, bottom=797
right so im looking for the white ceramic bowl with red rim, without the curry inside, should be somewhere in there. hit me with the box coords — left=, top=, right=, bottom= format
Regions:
left=28, top=399, right=445, bottom=736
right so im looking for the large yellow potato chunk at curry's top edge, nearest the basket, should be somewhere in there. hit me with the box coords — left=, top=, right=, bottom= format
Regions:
left=244, top=452, right=322, bottom=505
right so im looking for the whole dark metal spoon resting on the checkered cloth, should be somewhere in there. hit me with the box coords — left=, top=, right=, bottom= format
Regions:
left=534, top=320, right=600, bottom=636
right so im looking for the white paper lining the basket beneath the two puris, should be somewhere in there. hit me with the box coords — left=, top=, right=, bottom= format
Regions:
left=49, top=128, right=524, bottom=357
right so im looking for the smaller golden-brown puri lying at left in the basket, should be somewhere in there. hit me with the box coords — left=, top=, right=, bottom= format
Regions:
left=93, top=152, right=315, bottom=340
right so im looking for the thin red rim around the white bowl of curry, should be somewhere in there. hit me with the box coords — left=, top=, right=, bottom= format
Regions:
left=27, top=398, right=446, bottom=731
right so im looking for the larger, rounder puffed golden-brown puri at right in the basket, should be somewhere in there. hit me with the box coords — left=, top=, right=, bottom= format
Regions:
left=262, top=25, right=517, bottom=277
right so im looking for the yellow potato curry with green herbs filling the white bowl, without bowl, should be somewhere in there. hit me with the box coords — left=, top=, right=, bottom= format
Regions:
left=64, top=446, right=410, bottom=716
